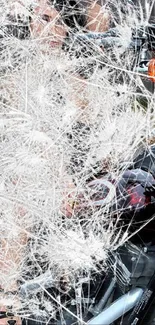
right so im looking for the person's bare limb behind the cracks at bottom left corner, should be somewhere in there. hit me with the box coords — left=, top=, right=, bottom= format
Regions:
left=0, top=230, right=28, bottom=325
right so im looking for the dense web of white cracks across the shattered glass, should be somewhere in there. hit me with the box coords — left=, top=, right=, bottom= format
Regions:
left=0, top=1, right=154, bottom=319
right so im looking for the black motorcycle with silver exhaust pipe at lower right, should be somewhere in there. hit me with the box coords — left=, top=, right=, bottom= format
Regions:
left=3, top=146, right=155, bottom=325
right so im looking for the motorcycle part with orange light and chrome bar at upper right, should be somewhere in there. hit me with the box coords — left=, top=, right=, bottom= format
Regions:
left=65, top=24, right=155, bottom=93
